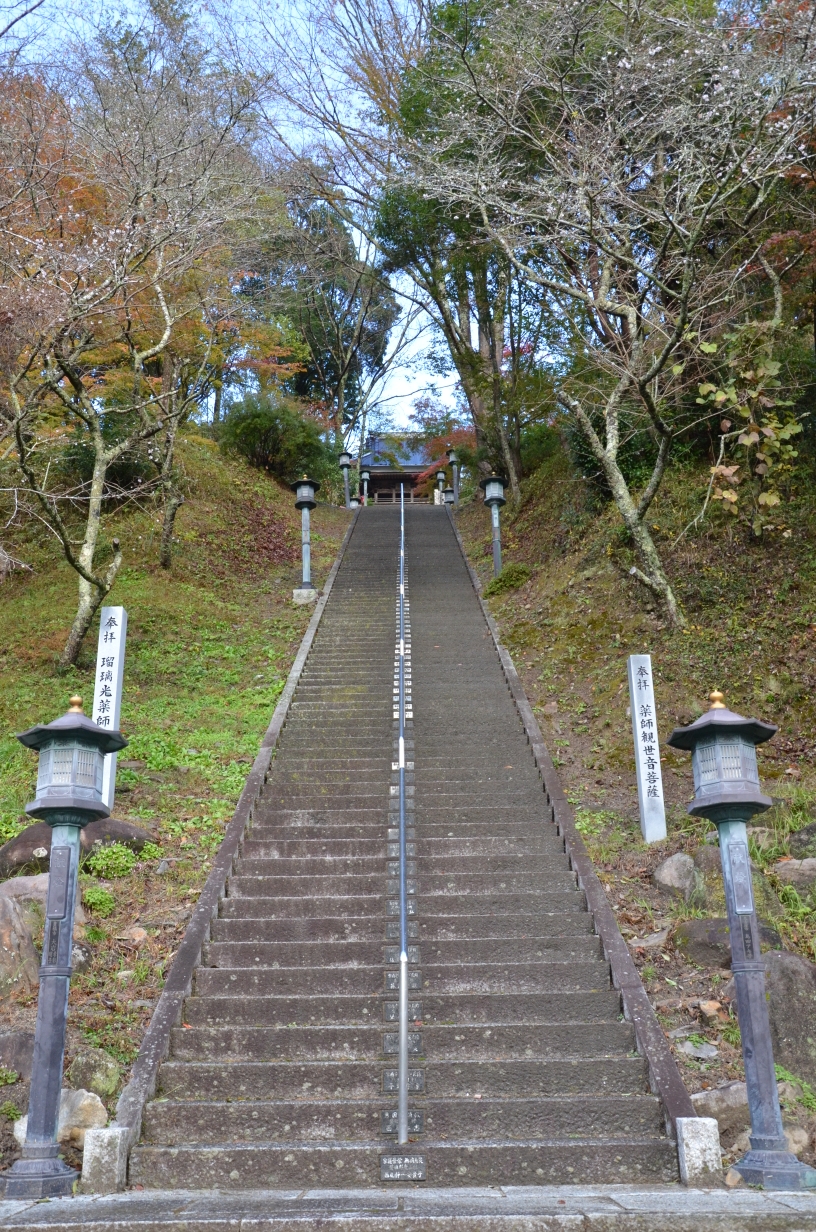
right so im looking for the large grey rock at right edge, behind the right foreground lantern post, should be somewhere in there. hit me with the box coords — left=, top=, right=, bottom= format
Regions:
left=763, top=951, right=816, bottom=1085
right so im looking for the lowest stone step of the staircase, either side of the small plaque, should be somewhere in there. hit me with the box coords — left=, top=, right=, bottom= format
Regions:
left=129, top=1136, right=677, bottom=1187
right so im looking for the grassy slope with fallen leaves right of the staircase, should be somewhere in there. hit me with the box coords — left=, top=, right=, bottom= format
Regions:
left=459, top=453, right=816, bottom=1153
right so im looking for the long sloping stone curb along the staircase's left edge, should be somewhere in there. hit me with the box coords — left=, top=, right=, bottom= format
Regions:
left=80, top=510, right=359, bottom=1194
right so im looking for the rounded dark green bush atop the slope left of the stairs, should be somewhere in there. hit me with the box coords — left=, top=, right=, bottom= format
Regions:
left=219, top=394, right=334, bottom=479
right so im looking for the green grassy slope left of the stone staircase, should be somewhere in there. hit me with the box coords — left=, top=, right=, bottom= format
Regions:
left=0, top=436, right=349, bottom=1164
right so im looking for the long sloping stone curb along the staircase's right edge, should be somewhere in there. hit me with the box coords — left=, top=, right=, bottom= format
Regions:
left=447, top=510, right=716, bottom=1153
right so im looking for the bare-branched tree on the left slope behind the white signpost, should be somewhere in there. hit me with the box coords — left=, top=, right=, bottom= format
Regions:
left=0, top=14, right=269, bottom=664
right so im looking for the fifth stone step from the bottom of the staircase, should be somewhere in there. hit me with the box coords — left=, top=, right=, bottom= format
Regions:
left=185, top=988, right=620, bottom=1026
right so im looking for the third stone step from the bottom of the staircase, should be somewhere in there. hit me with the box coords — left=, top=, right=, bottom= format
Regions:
left=158, top=1056, right=647, bottom=1101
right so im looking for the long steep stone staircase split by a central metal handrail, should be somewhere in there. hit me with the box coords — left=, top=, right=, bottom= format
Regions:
left=129, top=506, right=677, bottom=1190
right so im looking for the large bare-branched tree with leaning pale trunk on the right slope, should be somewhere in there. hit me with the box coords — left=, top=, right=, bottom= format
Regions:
left=402, top=0, right=814, bottom=625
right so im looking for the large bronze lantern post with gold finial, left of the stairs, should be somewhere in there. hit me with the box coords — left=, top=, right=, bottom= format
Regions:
left=4, top=697, right=127, bottom=1199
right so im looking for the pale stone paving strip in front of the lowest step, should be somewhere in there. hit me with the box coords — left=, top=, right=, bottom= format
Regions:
left=0, top=1185, right=816, bottom=1232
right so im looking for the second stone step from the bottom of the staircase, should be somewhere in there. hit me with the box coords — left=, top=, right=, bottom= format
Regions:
left=143, top=1095, right=663, bottom=1146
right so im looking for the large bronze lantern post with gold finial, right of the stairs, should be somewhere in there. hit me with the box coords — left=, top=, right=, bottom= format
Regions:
left=668, top=691, right=816, bottom=1190
